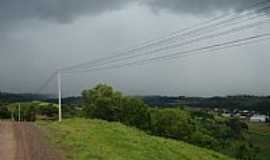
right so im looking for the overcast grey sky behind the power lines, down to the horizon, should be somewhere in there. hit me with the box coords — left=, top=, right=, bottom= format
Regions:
left=0, top=0, right=270, bottom=96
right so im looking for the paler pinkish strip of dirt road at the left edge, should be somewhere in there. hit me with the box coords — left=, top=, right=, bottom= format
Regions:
left=0, top=122, right=16, bottom=160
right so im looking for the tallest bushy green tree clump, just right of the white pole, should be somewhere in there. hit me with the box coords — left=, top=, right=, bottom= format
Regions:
left=82, top=84, right=150, bottom=129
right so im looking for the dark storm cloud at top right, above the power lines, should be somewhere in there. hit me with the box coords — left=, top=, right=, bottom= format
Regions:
left=145, top=0, right=270, bottom=15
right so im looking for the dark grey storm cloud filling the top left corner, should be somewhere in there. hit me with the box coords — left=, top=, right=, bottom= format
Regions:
left=0, top=0, right=134, bottom=25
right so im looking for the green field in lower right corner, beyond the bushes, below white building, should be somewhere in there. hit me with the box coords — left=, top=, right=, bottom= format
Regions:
left=249, top=123, right=270, bottom=160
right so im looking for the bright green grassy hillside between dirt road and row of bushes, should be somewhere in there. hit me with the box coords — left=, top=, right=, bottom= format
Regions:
left=37, top=119, right=231, bottom=160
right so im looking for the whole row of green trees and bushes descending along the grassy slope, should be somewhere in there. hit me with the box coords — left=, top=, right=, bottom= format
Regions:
left=82, top=84, right=257, bottom=160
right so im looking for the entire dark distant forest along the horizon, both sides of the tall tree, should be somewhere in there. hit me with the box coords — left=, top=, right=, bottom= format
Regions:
left=0, top=92, right=270, bottom=114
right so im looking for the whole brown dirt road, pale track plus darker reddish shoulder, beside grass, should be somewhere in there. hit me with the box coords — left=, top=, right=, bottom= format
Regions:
left=0, top=121, right=63, bottom=160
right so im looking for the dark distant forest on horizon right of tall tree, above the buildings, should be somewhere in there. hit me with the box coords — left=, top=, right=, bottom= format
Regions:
left=143, top=95, right=270, bottom=113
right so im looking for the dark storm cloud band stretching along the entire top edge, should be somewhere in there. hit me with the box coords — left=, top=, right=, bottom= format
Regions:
left=0, top=0, right=268, bottom=28
